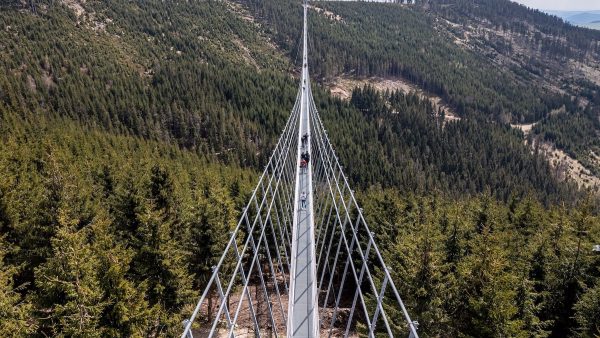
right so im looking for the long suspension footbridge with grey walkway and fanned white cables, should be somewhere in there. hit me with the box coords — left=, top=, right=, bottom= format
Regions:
left=181, top=1, right=418, bottom=338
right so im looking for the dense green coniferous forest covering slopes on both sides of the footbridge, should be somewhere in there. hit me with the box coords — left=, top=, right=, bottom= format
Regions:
left=0, top=0, right=600, bottom=337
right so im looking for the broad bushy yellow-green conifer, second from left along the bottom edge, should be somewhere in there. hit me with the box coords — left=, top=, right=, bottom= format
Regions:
left=35, top=208, right=107, bottom=337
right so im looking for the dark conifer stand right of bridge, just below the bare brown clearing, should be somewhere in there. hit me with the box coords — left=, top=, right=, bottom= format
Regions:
left=319, top=86, right=576, bottom=201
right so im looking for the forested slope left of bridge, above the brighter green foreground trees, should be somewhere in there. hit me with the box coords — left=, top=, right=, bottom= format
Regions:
left=0, top=1, right=295, bottom=166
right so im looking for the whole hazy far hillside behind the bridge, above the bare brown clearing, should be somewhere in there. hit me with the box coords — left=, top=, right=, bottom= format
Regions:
left=248, top=0, right=600, bottom=180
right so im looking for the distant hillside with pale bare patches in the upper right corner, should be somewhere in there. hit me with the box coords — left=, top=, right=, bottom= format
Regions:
left=430, top=0, right=600, bottom=180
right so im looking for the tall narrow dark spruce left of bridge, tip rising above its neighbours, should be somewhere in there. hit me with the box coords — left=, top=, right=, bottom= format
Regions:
left=132, top=166, right=193, bottom=334
